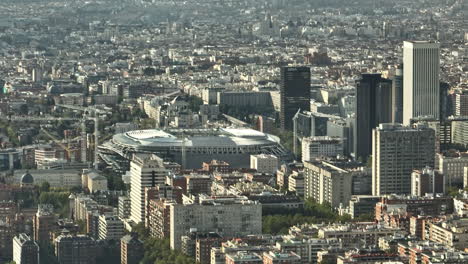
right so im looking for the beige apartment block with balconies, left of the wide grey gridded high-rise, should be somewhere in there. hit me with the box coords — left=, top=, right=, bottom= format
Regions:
left=304, top=161, right=353, bottom=207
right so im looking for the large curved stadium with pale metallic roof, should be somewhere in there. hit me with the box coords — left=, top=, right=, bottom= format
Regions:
left=99, top=128, right=292, bottom=172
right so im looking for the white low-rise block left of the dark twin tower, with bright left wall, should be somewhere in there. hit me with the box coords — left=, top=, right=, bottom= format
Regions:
left=302, top=136, right=343, bottom=162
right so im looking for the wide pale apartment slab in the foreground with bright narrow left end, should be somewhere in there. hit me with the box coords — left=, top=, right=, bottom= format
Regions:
left=170, top=195, right=262, bottom=249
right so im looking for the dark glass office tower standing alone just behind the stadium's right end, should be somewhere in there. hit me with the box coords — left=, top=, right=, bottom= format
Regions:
left=280, top=67, right=310, bottom=130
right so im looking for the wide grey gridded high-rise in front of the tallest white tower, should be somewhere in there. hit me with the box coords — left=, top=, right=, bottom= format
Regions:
left=372, top=124, right=435, bottom=195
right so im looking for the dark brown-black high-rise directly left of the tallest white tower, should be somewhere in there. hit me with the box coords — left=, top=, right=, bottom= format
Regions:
left=354, top=74, right=392, bottom=160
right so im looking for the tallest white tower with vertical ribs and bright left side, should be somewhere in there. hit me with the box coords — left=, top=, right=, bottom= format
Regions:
left=403, top=41, right=440, bottom=125
